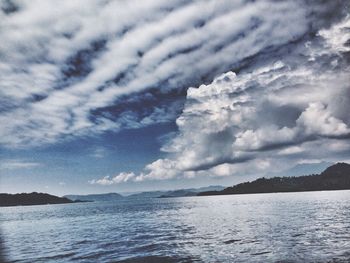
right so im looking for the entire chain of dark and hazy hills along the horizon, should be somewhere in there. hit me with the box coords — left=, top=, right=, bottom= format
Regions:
left=0, top=162, right=350, bottom=207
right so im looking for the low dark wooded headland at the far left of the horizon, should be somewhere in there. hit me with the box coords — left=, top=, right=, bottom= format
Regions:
left=0, top=192, right=74, bottom=206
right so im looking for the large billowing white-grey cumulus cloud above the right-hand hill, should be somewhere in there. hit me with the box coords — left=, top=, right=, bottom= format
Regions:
left=92, top=16, right=350, bottom=186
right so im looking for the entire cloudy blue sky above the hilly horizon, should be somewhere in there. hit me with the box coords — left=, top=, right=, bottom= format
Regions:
left=0, top=0, right=350, bottom=195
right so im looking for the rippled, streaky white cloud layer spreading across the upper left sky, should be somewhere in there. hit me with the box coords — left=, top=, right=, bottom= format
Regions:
left=0, top=0, right=342, bottom=148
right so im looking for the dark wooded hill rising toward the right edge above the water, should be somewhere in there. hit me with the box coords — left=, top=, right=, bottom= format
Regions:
left=198, top=163, right=350, bottom=196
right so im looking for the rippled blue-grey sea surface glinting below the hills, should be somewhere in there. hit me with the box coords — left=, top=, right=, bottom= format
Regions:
left=0, top=191, right=350, bottom=262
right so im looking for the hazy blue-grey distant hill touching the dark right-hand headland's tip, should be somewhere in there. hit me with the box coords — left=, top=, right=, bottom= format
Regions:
left=127, top=185, right=225, bottom=198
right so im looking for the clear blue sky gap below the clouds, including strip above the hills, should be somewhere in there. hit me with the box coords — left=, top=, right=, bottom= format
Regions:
left=1, top=123, right=252, bottom=195
